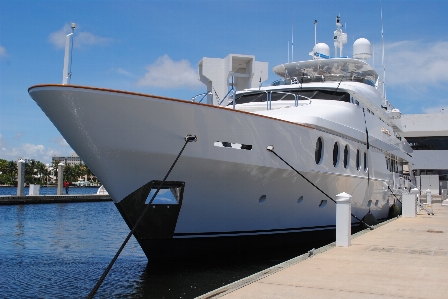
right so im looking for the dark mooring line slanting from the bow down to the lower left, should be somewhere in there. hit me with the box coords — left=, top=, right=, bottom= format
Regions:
left=87, top=135, right=198, bottom=299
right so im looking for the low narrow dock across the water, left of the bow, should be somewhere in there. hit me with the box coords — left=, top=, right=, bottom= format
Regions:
left=0, top=194, right=112, bottom=205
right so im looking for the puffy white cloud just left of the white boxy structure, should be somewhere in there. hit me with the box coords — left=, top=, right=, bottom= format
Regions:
left=137, top=54, right=202, bottom=89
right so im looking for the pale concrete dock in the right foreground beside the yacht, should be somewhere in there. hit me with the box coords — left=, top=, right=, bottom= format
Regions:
left=198, top=204, right=448, bottom=299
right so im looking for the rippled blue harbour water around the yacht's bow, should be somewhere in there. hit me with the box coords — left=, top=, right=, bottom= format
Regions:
left=0, top=188, right=328, bottom=298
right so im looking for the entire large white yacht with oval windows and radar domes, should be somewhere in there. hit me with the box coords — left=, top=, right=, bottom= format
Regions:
left=29, top=18, right=412, bottom=259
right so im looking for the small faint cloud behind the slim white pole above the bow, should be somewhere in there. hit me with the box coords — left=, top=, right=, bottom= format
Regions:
left=48, top=24, right=112, bottom=49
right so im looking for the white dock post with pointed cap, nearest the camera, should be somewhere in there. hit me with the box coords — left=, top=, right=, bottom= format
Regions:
left=336, top=192, right=352, bottom=247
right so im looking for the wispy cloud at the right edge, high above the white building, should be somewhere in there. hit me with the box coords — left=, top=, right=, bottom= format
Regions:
left=385, top=41, right=448, bottom=88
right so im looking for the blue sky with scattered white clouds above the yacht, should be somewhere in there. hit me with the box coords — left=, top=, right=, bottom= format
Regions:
left=0, top=0, right=448, bottom=163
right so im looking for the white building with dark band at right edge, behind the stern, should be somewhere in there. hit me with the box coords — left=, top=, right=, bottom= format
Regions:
left=400, top=113, right=448, bottom=194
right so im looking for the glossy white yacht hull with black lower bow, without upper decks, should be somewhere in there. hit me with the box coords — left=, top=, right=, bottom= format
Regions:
left=29, top=85, right=390, bottom=259
